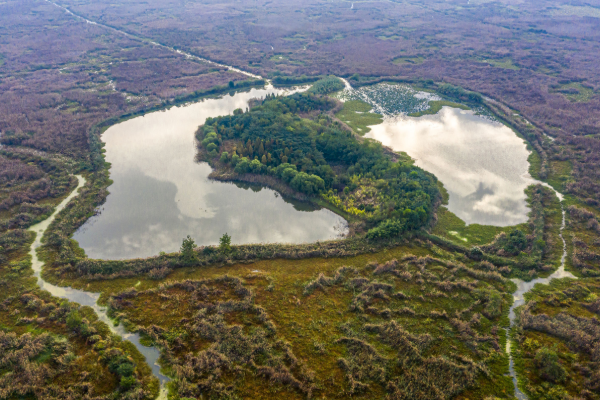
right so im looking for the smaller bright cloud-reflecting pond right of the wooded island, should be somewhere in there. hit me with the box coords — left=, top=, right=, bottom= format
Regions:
left=366, top=107, right=537, bottom=226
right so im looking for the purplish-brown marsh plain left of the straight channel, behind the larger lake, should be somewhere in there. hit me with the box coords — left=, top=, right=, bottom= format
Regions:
left=0, top=0, right=245, bottom=160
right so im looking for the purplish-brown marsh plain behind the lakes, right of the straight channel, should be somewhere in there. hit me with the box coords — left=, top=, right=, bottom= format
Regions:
left=44, top=0, right=600, bottom=206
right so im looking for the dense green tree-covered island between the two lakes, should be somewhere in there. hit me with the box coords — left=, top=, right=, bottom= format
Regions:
left=197, top=93, right=439, bottom=239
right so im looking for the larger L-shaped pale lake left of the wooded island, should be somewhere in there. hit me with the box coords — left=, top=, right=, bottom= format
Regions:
left=73, top=88, right=347, bottom=259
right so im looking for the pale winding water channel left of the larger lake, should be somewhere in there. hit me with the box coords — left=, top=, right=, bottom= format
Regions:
left=28, top=175, right=169, bottom=399
